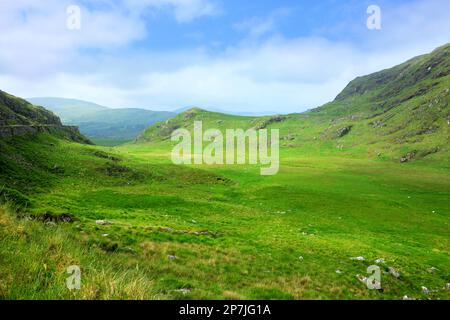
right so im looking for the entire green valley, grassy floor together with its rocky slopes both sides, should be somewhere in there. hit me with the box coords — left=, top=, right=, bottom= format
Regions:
left=0, top=44, right=450, bottom=300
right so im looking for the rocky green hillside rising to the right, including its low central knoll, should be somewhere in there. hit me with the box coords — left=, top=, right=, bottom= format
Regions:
left=138, top=44, right=450, bottom=163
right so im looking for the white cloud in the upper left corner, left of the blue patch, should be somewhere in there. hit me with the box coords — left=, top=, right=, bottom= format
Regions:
left=0, top=0, right=146, bottom=77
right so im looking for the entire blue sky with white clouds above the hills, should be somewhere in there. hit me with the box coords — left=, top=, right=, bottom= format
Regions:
left=0, top=0, right=450, bottom=113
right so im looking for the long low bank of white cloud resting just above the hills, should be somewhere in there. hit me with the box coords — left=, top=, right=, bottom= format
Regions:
left=0, top=38, right=430, bottom=112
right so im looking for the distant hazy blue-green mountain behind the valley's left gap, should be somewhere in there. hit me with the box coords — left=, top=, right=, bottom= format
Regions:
left=28, top=98, right=175, bottom=144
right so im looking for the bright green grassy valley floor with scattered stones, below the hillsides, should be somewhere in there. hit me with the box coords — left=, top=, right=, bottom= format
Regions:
left=0, top=131, right=450, bottom=299
